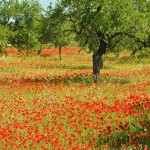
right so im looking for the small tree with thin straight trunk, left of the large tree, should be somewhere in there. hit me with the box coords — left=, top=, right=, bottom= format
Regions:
left=40, top=5, right=72, bottom=60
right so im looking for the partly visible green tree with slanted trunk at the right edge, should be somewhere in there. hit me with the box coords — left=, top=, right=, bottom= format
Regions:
left=127, top=0, right=150, bottom=58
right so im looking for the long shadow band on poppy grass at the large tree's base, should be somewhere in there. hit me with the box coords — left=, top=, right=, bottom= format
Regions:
left=0, top=75, right=130, bottom=85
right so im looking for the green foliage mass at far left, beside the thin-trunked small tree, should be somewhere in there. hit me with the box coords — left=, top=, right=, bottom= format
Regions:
left=0, top=0, right=42, bottom=50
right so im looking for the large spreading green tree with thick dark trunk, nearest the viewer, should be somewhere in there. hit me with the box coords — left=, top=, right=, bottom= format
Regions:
left=45, top=0, right=149, bottom=83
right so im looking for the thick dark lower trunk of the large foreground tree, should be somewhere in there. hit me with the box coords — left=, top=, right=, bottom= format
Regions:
left=93, top=52, right=103, bottom=83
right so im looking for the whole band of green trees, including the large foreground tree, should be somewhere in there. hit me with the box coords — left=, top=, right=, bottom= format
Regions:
left=0, top=0, right=150, bottom=82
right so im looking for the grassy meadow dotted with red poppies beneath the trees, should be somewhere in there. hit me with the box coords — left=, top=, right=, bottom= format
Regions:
left=0, top=48, right=150, bottom=150
